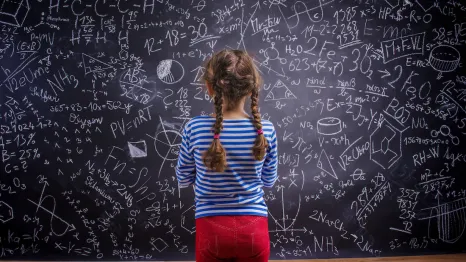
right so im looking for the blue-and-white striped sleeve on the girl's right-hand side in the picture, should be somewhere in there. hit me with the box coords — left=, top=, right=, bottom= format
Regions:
left=261, top=125, right=278, bottom=188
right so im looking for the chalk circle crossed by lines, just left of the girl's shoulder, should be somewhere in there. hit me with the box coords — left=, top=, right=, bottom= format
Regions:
left=154, top=130, right=181, bottom=161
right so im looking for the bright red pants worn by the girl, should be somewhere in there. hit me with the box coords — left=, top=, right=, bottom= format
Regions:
left=196, top=216, right=270, bottom=262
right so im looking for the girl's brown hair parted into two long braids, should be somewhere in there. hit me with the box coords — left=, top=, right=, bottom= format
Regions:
left=203, top=50, right=268, bottom=172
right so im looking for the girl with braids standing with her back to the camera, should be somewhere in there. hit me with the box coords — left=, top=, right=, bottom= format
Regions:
left=176, top=50, right=278, bottom=261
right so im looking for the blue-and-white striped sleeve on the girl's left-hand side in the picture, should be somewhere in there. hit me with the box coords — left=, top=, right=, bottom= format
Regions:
left=175, top=123, right=196, bottom=188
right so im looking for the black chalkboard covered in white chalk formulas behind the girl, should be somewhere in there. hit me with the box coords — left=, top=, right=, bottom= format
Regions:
left=0, top=0, right=466, bottom=260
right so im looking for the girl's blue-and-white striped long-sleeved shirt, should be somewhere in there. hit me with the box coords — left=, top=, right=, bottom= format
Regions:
left=175, top=116, right=278, bottom=218
